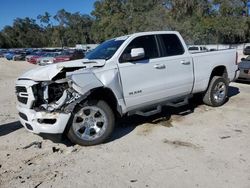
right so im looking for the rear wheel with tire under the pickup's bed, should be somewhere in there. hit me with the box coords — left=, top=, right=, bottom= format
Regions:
left=203, top=76, right=229, bottom=107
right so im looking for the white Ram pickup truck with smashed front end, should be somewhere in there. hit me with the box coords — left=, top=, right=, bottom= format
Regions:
left=16, top=31, right=239, bottom=145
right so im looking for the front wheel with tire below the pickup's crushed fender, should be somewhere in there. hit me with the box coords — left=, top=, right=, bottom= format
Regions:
left=67, top=100, right=115, bottom=146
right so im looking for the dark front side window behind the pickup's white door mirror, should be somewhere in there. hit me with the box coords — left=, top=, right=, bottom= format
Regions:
left=120, top=35, right=159, bottom=62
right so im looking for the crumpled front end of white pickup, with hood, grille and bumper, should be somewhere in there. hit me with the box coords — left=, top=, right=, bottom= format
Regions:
left=16, top=60, right=106, bottom=134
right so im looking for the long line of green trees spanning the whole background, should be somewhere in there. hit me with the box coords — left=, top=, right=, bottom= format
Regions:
left=0, top=0, right=250, bottom=48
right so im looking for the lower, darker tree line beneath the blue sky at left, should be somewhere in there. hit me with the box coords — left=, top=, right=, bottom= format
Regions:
left=0, top=9, right=93, bottom=48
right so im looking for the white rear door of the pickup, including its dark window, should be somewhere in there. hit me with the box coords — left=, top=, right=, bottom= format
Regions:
left=158, top=34, right=194, bottom=99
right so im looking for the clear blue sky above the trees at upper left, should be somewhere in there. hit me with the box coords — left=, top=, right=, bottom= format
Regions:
left=0, top=0, right=95, bottom=30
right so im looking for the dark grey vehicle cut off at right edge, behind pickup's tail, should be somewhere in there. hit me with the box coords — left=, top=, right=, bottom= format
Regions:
left=238, top=56, right=250, bottom=81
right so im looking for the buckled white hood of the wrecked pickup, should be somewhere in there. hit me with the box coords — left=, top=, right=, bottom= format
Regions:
left=19, top=59, right=106, bottom=81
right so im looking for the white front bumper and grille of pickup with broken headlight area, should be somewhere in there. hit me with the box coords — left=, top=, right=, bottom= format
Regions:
left=16, top=80, right=82, bottom=134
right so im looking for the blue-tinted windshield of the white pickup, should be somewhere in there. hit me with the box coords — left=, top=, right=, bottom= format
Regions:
left=86, top=39, right=125, bottom=60
